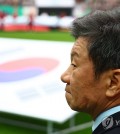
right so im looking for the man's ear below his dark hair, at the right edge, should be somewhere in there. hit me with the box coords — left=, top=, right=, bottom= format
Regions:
left=106, top=69, right=120, bottom=97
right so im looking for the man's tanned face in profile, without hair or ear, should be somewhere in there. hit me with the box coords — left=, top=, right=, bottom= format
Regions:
left=61, top=37, right=106, bottom=117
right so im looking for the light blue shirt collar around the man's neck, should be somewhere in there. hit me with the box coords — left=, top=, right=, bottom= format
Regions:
left=92, top=106, right=120, bottom=131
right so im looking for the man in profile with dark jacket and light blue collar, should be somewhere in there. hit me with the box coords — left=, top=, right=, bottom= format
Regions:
left=61, top=9, right=120, bottom=134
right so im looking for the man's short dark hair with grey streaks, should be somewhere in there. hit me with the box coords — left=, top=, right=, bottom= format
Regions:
left=70, top=8, right=120, bottom=76
